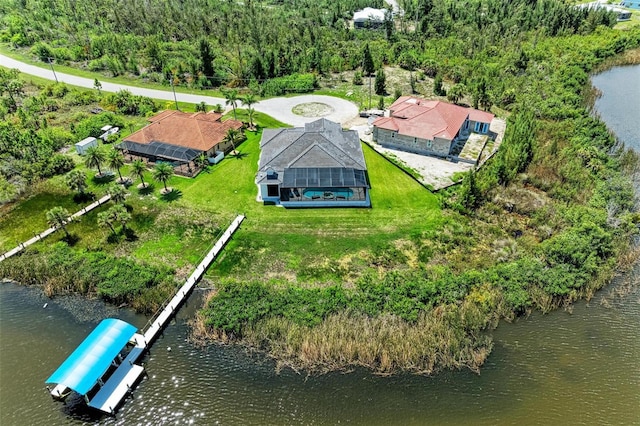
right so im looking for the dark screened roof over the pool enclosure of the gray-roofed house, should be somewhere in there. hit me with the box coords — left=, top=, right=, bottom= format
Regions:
left=282, top=167, right=369, bottom=188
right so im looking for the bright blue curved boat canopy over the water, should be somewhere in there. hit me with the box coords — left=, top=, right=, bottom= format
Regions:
left=46, top=318, right=137, bottom=395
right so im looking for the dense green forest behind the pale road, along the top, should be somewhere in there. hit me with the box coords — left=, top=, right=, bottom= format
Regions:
left=0, top=0, right=615, bottom=108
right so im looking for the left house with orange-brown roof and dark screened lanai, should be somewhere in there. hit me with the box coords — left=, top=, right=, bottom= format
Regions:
left=116, top=110, right=242, bottom=176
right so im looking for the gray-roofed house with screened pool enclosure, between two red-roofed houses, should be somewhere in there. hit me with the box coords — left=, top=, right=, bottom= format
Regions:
left=255, top=118, right=371, bottom=207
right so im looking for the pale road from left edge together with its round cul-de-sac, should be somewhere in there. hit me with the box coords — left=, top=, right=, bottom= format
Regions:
left=0, top=55, right=358, bottom=127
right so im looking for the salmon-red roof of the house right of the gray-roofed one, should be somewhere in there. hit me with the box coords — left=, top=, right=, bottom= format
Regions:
left=373, top=96, right=494, bottom=140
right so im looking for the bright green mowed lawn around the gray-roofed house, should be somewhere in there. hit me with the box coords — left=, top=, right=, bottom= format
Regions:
left=0, top=125, right=442, bottom=276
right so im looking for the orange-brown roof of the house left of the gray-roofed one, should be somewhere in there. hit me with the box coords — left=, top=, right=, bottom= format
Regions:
left=125, top=111, right=242, bottom=151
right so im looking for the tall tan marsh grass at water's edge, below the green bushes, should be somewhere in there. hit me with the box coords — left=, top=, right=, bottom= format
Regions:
left=192, top=287, right=505, bottom=375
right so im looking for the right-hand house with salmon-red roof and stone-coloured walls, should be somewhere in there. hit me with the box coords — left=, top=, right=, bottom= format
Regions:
left=373, top=96, right=494, bottom=157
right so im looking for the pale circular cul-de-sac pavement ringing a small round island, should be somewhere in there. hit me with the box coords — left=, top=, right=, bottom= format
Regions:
left=254, top=95, right=359, bottom=127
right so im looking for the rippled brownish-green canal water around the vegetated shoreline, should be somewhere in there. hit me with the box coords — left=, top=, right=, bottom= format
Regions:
left=0, top=66, right=640, bottom=425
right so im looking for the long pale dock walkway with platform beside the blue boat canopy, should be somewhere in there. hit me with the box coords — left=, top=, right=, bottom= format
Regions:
left=88, top=215, right=245, bottom=414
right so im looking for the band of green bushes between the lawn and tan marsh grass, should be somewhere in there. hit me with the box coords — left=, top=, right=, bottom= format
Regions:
left=205, top=211, right=613, bottom=336
